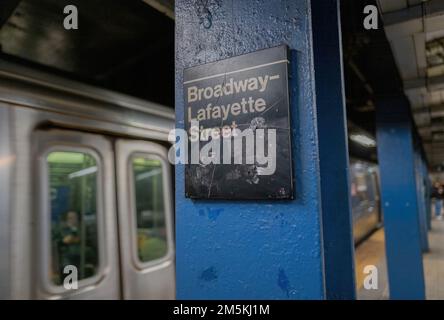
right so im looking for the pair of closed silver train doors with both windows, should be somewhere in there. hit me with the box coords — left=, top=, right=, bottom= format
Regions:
left=34, top=130, right=175, bottom=299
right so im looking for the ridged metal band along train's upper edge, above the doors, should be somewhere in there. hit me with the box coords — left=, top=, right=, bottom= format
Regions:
left=0, top=61, right=174, bottom=140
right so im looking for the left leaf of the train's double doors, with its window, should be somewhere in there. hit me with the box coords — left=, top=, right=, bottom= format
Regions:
left=33, top=130, right=121, bottom=299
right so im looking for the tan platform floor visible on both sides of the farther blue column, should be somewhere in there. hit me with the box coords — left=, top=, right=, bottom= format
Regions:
left=355, top=219, right=444, bottom=300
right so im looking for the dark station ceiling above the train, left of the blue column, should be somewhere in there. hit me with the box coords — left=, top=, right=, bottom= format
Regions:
left=0, top=0, right=174, bottom=107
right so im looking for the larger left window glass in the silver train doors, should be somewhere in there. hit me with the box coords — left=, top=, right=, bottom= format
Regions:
left=46, top=151, right=99, bottom=285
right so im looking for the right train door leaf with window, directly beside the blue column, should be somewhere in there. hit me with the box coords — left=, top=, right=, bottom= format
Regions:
left=116, top=139, right=175, bottom=299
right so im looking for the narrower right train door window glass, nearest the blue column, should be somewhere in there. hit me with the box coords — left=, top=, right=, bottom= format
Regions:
left=131, top=156, right=168, bottom=262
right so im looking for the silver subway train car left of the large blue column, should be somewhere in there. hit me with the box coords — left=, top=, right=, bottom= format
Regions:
left=0, top=62, right=175, bottom=299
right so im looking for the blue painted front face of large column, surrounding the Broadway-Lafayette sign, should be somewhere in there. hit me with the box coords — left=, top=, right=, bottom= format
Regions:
left=176, top=0, right=325, bottom=299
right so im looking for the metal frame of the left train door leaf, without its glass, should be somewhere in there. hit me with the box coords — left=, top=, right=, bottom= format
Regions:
left=33, top=130, right=120, bottom=299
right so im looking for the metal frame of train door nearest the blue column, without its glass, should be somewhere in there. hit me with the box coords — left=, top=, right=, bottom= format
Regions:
left=116, top=140, right=175, bottom=299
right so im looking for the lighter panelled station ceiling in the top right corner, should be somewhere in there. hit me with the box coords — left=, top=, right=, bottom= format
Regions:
left=378, top=0, right=444, bottom=170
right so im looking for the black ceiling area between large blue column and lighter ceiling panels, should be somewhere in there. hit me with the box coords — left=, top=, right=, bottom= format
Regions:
left=341, top=0, right=403, bottom=161
